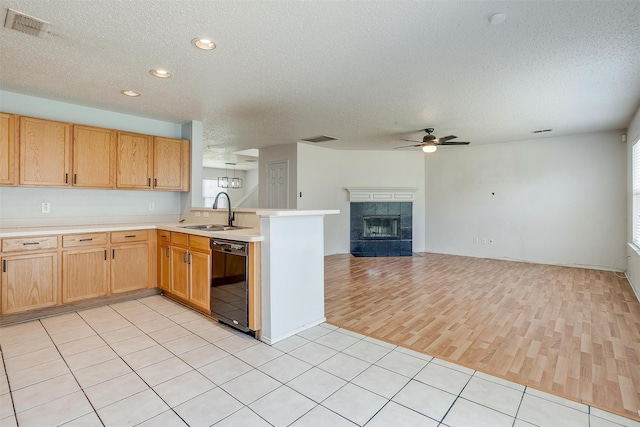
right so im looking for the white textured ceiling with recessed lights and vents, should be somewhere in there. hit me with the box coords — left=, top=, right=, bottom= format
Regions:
left=0, top=0, right=640, bottom=166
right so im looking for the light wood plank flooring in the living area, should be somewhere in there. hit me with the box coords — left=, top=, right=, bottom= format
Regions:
left=325, top=253, right=640, bottom=420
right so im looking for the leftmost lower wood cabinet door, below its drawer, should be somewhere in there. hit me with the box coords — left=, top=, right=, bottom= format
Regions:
left=2, top=253, right=58, bottom=314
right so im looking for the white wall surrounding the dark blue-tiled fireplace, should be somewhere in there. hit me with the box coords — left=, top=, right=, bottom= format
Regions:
left=297, top=144, right=425, bottom=255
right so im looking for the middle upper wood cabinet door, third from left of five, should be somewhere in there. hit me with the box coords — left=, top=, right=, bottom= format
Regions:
left=72, top=125, right=116, bottom=188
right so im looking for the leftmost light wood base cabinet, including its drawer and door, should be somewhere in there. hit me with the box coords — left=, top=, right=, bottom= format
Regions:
left=1, top=237, right=59, bottom=314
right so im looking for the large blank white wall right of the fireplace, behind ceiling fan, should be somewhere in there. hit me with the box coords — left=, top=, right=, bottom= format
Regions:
left=425, top=131, right=627, bottom=270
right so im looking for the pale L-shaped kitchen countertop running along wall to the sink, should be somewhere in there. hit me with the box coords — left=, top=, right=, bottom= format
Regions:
left=0, top=222, right=264, bottom=242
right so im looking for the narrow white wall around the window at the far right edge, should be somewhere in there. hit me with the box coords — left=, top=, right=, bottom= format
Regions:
left=626, top=104, right=640, bottom=299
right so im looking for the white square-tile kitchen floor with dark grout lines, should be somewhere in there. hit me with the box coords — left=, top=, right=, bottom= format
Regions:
left=0, top=296, right=640, bottom=427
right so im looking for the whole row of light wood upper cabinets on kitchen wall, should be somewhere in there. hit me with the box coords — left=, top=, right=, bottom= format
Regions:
left=0, top=112, right=191, bottom=191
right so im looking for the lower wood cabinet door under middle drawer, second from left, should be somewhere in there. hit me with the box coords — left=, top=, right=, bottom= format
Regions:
left=62, top=247, right=109, bottom=304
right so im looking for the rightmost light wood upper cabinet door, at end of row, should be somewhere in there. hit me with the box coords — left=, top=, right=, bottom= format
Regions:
left=153, top=136, right=191, bottom=191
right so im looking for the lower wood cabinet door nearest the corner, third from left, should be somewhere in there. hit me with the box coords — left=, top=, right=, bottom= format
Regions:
left=111, top=243, right=149, bottom=294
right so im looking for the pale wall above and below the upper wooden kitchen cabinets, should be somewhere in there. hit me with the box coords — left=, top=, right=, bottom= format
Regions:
left=0, top=91, right=188, bottom=224
